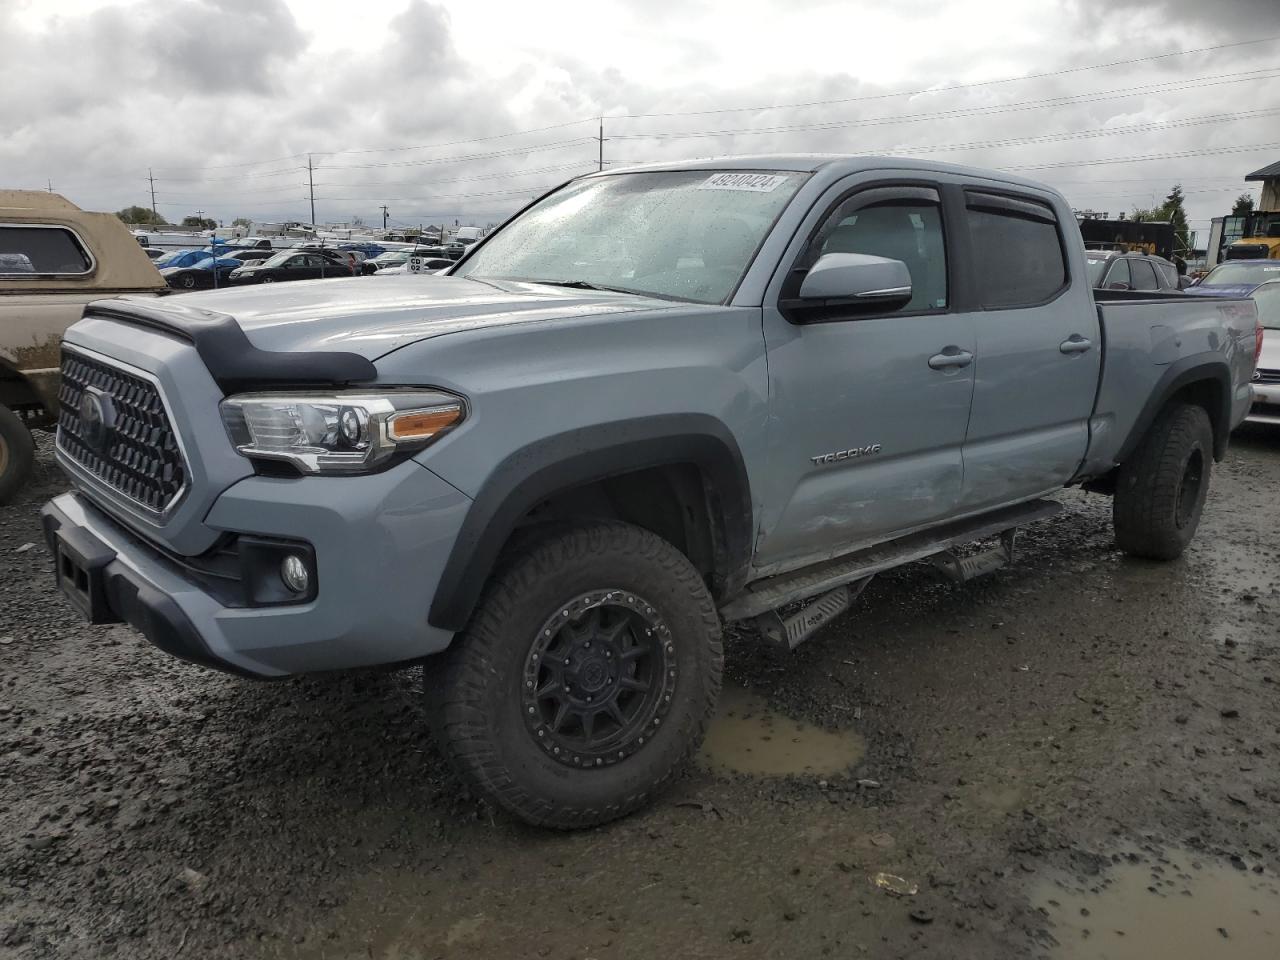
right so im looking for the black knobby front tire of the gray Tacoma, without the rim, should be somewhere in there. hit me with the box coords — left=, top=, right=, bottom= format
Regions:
left=424, top=521, right=723, bottom=829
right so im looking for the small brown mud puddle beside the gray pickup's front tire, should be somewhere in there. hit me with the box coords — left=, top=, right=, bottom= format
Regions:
left=698, top=685, right=867, bottom=777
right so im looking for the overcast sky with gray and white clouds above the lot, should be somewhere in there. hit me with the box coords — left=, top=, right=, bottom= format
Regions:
left=0, top=0, right=1280, bottom=239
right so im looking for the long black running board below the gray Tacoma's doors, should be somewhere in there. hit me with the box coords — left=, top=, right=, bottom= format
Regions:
left=721, top=500, right=1062, bottom=621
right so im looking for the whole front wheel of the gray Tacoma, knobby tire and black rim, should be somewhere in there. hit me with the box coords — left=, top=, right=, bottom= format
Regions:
left=425, top=522, right=723, bottom=829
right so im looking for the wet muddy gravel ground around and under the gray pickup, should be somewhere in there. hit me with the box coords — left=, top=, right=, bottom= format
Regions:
left=0, top=430, right=1280, bottom=960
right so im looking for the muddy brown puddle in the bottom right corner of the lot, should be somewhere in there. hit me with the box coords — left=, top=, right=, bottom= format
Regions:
left=1033, top=852, right=1280, bottom=960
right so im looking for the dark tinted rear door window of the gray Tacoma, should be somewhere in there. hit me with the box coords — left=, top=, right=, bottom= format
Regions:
left=965, top=192, right=1066, bottom=307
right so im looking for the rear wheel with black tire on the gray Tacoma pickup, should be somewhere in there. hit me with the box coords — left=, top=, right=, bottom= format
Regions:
left=1111, top=403, right=1213, bottom=561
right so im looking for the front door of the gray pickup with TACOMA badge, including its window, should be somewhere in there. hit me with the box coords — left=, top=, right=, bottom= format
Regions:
left=756, top=177, right=974, bottom=573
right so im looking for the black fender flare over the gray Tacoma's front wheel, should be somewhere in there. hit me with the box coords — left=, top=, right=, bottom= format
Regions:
left=428, top=413, right=754, bottom=632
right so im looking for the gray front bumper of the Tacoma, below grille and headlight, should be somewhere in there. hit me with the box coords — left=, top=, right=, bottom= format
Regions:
left=41, top=461, right=470, bottom=677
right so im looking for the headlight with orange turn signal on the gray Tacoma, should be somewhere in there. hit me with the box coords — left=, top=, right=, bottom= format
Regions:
left=221, top=390, right=466, bottom=474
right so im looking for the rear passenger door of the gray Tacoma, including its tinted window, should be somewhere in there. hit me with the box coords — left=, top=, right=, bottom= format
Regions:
left=960, top=187, right=1100, bottom=512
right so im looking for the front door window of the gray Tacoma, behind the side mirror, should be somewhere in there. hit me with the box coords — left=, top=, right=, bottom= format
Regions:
left=800, top=187, right=947, bottom=311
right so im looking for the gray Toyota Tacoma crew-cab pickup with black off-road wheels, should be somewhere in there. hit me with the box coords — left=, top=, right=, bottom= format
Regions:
left=44, top=156, right=1261, bottom=827
